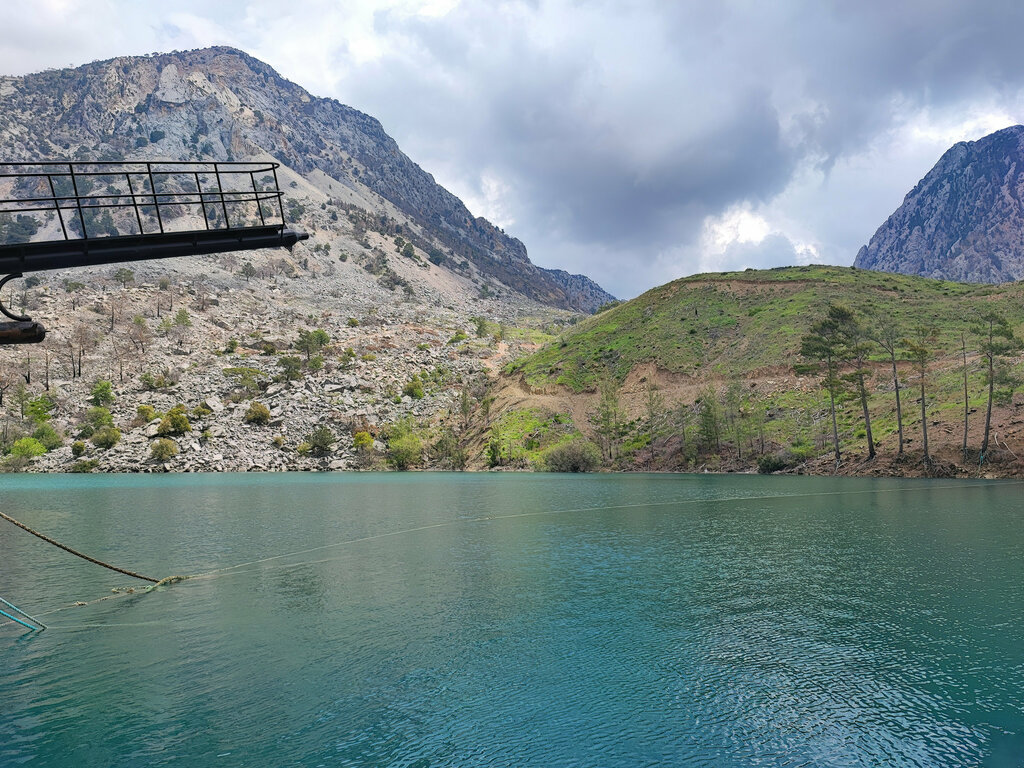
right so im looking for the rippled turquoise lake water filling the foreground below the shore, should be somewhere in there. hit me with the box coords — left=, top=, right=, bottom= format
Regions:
left=0, top=473, right=1024, bottom=768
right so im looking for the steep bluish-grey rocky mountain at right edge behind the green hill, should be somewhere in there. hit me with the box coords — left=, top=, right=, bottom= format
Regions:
left=854, top=125, right=1024, bottom=283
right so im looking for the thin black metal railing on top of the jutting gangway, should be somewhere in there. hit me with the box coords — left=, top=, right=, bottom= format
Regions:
left=0, top=156, right=285, bottom=239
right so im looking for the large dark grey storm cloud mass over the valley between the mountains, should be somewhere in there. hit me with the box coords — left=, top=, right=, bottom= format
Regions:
left=329, top=2, right=1024, bottom=294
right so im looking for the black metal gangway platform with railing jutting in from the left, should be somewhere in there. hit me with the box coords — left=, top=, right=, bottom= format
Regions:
left=0, top=161, right=308, bottom=345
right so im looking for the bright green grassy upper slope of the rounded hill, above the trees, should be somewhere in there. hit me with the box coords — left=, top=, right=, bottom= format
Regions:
left=507, top=266, right=1024, bottom=392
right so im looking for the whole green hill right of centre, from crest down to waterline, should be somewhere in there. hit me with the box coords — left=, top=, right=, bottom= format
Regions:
left=485, top=266, right=1024, bottom=474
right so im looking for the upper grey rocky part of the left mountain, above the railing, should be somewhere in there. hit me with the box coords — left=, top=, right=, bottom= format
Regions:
left=0, top=47, right=612, bottom=311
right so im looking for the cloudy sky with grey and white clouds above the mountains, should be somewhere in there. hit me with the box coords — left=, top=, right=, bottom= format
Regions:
left=0, top=0, right=1024, bottom=298
